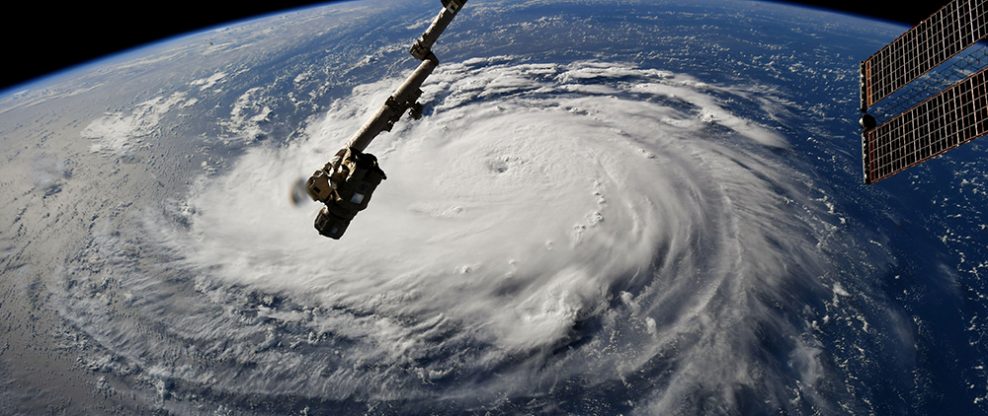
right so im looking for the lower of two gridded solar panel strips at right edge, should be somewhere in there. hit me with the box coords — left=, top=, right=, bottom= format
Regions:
left=864, top=69, right=988, bottom=183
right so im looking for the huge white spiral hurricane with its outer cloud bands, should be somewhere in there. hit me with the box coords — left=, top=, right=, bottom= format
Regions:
left=34, top=56, right=910, bottom=414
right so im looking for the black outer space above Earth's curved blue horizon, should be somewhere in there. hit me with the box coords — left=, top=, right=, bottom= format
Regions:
left=0, top=0, right=946, bottom=90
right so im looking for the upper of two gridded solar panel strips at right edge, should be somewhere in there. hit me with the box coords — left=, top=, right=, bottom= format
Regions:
left=861, top=0, right=988, bottom=109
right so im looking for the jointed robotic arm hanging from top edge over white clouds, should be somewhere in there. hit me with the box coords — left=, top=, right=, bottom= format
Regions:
left=305, top=0, right=467, bottom=239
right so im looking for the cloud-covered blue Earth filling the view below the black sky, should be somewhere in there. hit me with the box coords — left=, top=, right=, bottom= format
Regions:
left=0, top=0, right=988, bottom=415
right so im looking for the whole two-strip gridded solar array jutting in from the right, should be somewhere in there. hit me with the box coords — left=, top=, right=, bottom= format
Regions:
left=861, top=0, right=988, bottom=183
